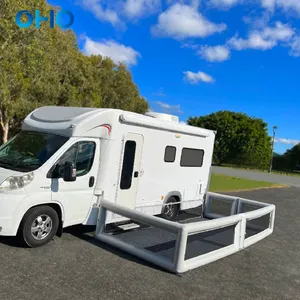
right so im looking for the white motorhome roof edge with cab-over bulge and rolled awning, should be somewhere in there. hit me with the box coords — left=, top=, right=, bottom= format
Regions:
left=22, top=106, right=213, bottom=137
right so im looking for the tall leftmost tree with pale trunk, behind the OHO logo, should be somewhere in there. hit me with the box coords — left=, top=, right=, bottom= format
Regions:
left=0, top=0, right=59, bottom=142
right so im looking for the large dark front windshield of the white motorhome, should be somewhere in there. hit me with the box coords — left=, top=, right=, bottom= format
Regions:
left=0, top=131, right=69, bottom=172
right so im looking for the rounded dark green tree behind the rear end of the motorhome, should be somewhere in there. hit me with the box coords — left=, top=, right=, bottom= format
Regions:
left=188, top=111, right=271, bottom=168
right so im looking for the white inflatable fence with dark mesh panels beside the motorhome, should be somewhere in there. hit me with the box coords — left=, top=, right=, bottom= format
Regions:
left=95, top=193, right=275, bottom=273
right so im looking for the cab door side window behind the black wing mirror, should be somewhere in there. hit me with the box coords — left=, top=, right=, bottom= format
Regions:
left=52, top=141, right=96, bottom=178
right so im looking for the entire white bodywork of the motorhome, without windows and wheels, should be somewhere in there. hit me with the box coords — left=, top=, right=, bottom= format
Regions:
left=0, top=107, right=215, bottom=235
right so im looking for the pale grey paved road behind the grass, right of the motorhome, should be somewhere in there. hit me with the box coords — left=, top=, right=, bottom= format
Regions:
left=212, top=167, right=300, bottom=188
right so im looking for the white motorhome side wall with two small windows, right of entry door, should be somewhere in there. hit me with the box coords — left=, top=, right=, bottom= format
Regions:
left=137, top=129, right=213, bottom=214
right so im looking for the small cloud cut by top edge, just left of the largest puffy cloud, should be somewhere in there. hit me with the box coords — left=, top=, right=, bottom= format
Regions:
left=123, top=0, right=161, bottom=19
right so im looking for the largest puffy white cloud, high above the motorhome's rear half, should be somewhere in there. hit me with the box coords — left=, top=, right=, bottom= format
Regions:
left=152, top=3, right=226, bottom=39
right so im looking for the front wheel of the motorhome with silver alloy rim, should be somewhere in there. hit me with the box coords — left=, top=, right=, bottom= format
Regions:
left=19, top=206, right=59, bottom=248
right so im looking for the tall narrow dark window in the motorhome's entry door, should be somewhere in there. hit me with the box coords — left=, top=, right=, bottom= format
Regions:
left=120, top=141, right=136, bottom=190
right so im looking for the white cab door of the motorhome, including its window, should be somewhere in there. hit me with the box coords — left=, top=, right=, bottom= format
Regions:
left=51, top=138, right=100, bottom=226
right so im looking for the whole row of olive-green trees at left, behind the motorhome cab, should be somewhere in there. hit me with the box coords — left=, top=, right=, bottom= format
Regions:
left=0, top=0, right=149, bottom=142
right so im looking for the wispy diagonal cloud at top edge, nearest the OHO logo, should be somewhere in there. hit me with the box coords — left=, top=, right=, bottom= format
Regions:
left=80, top=0, right=124, bottom=27
